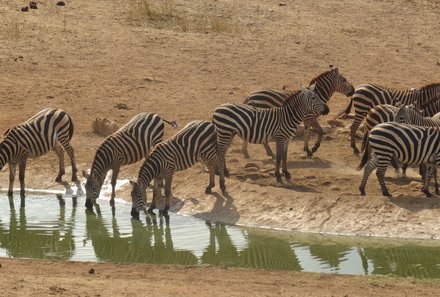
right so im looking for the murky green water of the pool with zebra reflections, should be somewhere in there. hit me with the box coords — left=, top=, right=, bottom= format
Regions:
left=0, top=194, right=440, bottom=278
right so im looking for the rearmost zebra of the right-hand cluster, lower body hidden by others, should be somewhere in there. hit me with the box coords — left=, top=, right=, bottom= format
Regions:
left=338, top=83, right=440, bottom=154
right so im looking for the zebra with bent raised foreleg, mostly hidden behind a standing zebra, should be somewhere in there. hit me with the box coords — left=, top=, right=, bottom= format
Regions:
left=242, top=65, right=354, bottom=158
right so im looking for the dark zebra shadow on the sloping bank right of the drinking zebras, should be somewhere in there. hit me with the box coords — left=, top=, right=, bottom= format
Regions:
left=194, top=193, right=240, bottom=224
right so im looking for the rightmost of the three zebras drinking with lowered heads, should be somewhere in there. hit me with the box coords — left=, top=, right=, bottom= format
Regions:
left=131, top=121, right=226, bottom=217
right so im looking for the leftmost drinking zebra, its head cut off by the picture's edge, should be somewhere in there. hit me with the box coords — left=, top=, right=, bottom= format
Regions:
left=0, top=108, right=77, bottom=198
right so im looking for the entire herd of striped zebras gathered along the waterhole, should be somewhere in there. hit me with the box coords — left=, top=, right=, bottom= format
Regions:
left=0, top=66, right=440, bottom=217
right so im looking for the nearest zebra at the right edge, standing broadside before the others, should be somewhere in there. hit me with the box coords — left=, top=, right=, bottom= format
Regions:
left=358, top=122, right=440, bottom=197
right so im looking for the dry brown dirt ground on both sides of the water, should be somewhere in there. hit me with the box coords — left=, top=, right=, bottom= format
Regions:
left=0, top=0, right=440, bottom=296
